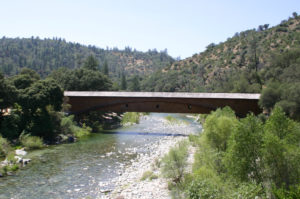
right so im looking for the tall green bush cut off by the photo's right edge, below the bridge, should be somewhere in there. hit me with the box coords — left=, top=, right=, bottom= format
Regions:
left=262, top=107, right=300, bottom=189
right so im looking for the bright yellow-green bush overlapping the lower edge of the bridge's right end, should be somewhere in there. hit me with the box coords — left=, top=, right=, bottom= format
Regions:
left=204, top=107, right=237, bottom=151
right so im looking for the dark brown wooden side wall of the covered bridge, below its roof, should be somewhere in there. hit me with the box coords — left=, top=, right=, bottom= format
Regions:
left=65, top=92, right=262, bottom=116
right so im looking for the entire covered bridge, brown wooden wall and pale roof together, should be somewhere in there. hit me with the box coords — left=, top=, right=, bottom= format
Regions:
left=64, top=91, right=261, bottom=116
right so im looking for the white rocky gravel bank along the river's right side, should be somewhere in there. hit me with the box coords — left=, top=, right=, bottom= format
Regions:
left=98, top=116, right=198, bottom=199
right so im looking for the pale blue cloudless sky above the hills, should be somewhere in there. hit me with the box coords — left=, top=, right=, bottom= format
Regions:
left=0, top=0, right=300, bottom=59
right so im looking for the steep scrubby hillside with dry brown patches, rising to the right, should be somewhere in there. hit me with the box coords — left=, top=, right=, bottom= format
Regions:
left=142, top=13, right=300, bottom=92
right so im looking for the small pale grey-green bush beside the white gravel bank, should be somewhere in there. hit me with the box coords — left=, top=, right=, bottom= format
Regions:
left=161, top=142, right=188, bottom=183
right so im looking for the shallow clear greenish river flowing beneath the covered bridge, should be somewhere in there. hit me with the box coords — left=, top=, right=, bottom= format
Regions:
left=0, top=113, right=201, bottom=199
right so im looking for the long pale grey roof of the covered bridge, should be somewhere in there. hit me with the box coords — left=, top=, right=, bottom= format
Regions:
left=64, top=91, right=260, bottom=100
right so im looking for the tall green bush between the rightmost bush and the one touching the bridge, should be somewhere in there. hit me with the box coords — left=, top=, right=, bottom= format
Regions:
left=224, top=114, right=263, bottom=182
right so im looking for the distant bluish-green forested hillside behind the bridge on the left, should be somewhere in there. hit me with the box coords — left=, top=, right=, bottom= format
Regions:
left=0, top=37, right=174, bottom=79
